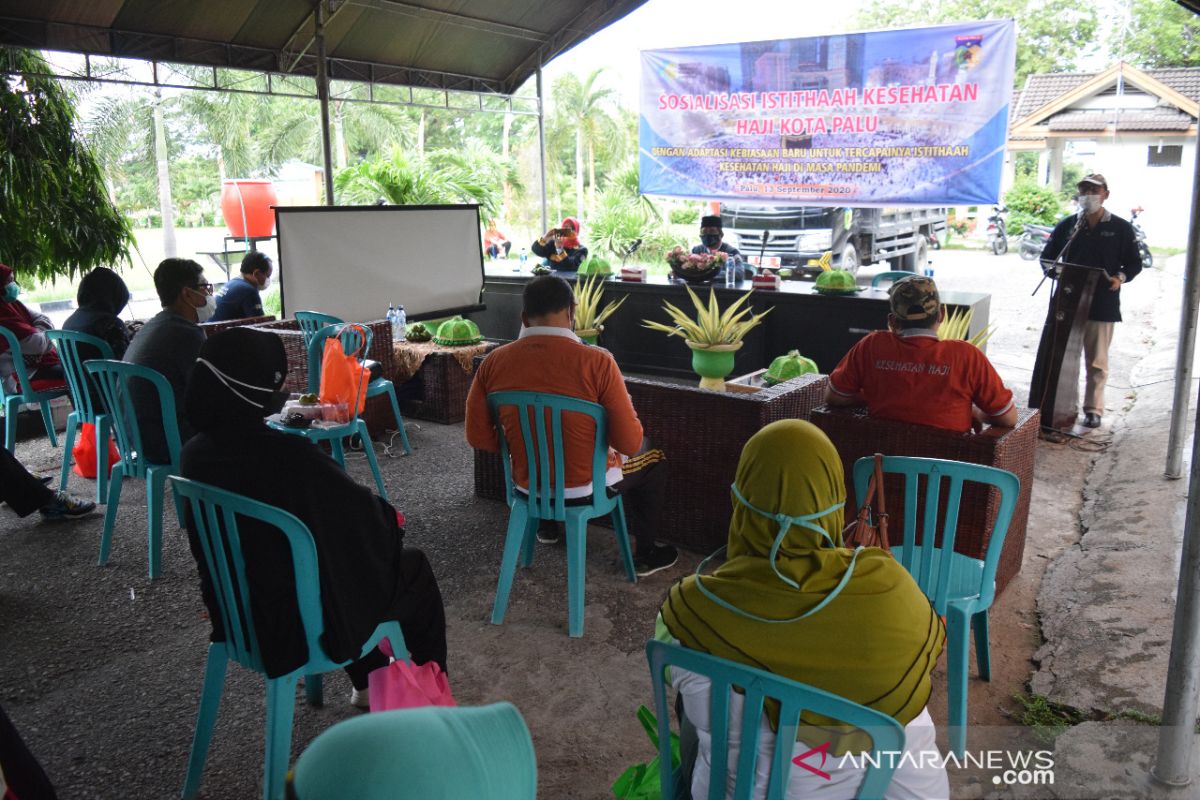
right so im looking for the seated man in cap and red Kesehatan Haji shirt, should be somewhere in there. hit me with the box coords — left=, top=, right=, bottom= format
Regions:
left=826, top=275, right=1016, bottom=433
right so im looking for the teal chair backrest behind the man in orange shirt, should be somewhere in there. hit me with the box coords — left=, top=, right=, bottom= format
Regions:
left=487, top=391, right=608, bottom=519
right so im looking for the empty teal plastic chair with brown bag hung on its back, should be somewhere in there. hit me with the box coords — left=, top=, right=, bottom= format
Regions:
left=854, top=456, right=1021, bottom=757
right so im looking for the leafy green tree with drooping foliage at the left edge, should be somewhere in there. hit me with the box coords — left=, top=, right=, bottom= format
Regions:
left=0, top=50, right=132, bottom=281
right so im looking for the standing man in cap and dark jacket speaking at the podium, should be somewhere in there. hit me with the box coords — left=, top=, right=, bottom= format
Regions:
left=1042, top=173, right=1141, bottom=428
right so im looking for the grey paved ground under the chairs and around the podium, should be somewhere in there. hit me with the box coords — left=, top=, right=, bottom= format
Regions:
left=0, top=252, right=1198, bottom=800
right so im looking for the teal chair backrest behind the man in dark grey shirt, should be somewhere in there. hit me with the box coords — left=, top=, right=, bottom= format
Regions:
left=84, top=359, right=180, bottom=477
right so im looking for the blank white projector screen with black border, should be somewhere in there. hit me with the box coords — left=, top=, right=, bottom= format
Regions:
left=275, top=205, right=484, bottom=321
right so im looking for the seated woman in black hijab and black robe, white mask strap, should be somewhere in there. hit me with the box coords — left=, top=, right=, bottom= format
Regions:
left=180, top=327, right=446, bottom=708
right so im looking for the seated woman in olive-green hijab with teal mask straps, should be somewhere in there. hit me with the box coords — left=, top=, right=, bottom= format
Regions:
left=659, top=420, right=949, bottom=800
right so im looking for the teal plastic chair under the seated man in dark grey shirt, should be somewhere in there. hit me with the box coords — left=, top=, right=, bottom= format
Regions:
left=84, top=359, right=184, bottom=581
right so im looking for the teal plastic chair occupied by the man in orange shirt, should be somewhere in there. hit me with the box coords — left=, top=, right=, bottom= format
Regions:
left=487, top=391, right=637, bottom=638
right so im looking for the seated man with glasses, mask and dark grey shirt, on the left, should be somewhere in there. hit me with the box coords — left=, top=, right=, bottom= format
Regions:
left=124, top=258, right=216, bottom=464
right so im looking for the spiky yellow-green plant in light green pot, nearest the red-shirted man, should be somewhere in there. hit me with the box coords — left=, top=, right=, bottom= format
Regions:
left=642, top=287, right=770, bottom=392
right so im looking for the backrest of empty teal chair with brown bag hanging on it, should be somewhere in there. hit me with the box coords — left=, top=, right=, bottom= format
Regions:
left=854, top=456, right=1021, bottom=614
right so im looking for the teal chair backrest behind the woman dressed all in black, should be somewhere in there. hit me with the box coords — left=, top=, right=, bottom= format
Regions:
left=172, top=476, right=337, bottom=673
